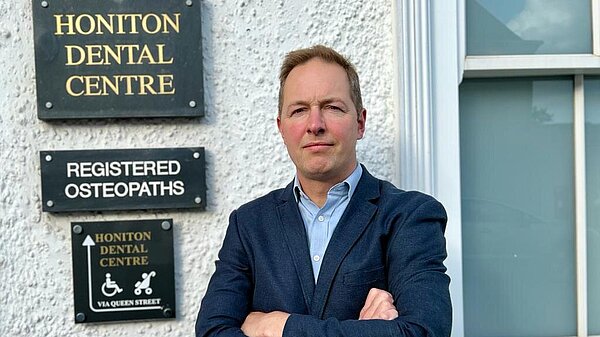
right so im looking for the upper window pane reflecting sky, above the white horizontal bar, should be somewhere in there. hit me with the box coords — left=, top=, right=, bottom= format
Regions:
left=466, top=0, right=592, bottom=55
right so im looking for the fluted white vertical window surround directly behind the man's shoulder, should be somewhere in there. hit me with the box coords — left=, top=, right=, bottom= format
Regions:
left=394, top=0, right=465, bottom=337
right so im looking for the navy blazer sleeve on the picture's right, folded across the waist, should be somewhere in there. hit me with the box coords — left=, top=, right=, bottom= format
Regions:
left=283, top=199, right=452, bottom=337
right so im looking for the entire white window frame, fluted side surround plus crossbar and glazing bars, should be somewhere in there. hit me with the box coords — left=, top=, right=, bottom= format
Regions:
left=394, top=0, right=600, bottom=337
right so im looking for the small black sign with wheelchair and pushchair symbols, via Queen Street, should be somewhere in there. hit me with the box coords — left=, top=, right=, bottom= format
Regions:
left=71, top=219, right=175, bottom=323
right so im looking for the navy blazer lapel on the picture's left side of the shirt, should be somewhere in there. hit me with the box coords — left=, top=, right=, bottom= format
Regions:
left=277, top=184, right=315, bottom=310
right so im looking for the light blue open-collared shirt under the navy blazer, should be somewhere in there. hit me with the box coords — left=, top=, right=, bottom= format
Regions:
left=294, top=165, right=363, bottom=283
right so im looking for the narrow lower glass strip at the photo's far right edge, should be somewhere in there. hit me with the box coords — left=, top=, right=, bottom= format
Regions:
left=585, top=77, right=600, bottom=335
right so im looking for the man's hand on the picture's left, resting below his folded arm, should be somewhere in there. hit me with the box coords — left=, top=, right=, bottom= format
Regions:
left=242, top=311, right=290, bottom=337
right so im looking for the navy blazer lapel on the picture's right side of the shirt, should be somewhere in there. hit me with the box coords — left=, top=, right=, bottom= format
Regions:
left=309, top=167, right=379, bottom=318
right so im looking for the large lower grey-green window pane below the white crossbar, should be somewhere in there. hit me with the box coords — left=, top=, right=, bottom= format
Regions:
left=460, top=78, right=576, bottom=337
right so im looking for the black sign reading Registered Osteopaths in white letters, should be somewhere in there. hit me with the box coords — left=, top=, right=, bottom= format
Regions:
left=40, top=147, right=206, bottom=212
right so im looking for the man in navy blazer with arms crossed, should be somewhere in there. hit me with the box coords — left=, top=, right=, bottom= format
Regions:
left=196, top=45, right=451, bottom=337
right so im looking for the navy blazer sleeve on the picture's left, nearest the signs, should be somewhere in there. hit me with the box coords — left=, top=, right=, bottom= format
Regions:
left=196, top=211, right=252, bottom=337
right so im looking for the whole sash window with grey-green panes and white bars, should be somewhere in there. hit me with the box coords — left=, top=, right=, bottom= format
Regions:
left=458, top=0, right=600, bottom=337
